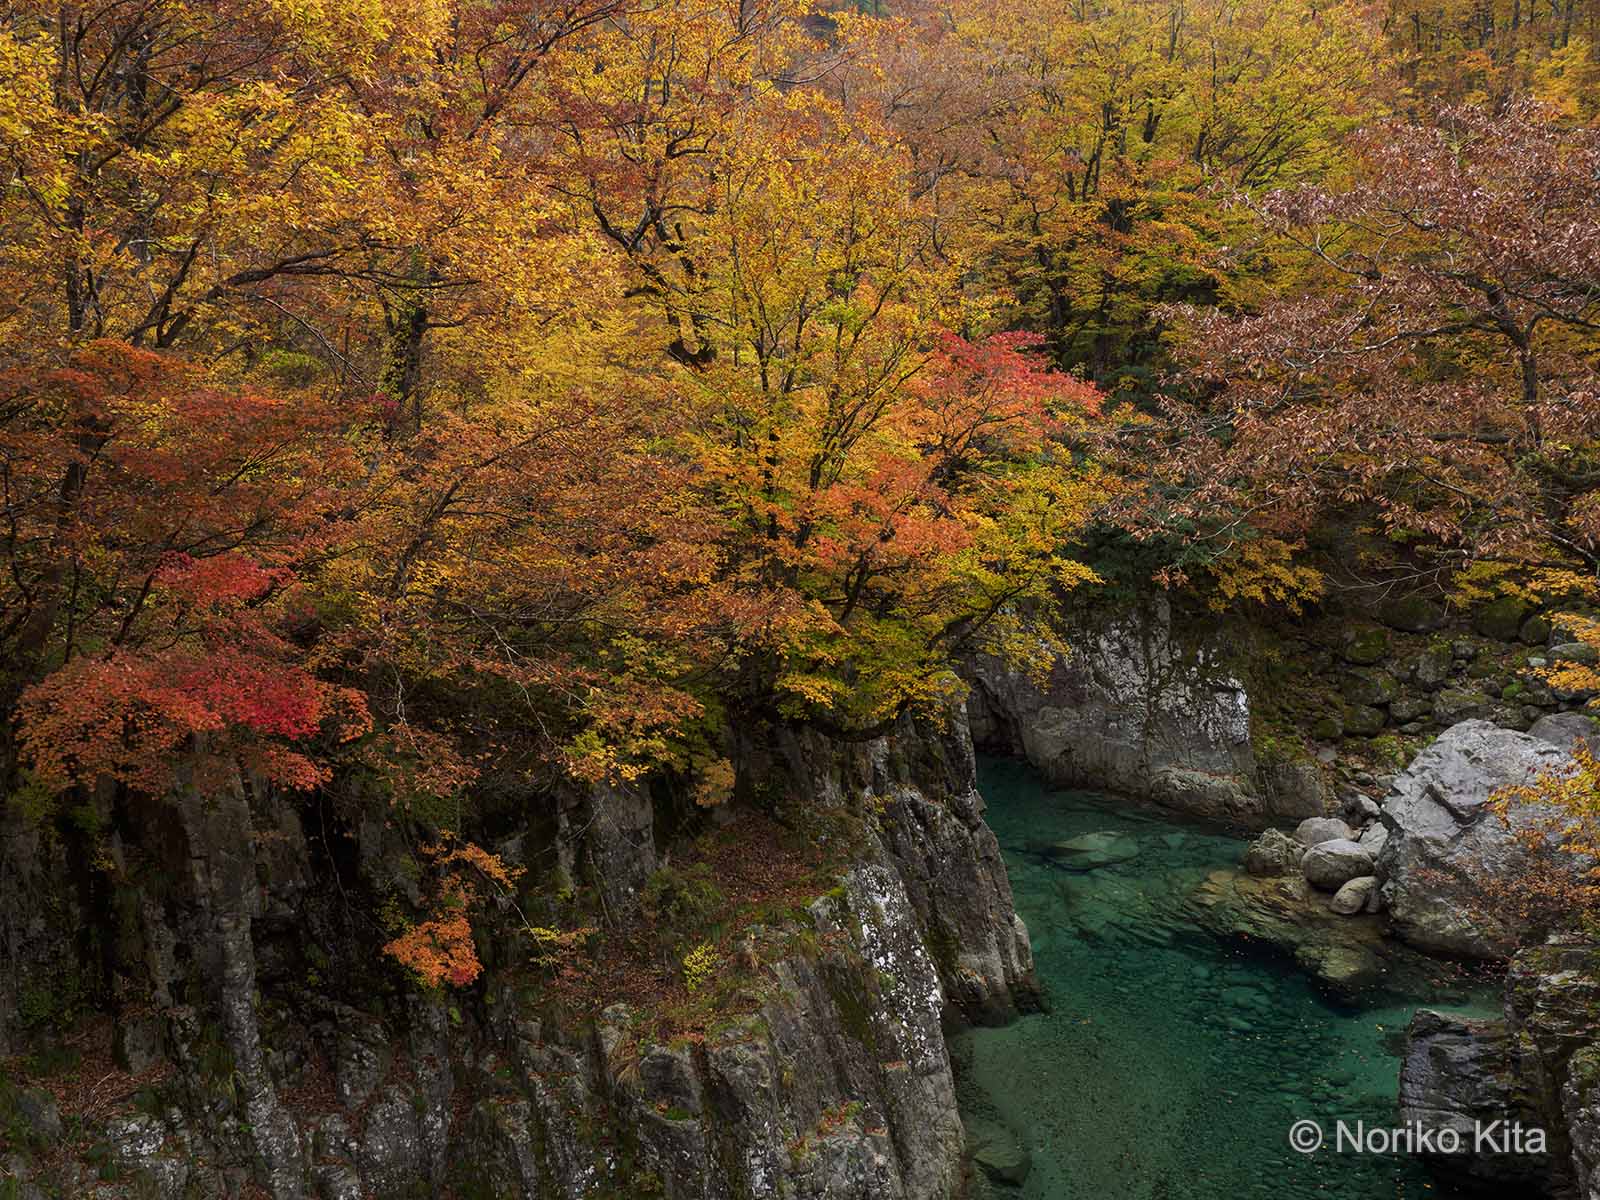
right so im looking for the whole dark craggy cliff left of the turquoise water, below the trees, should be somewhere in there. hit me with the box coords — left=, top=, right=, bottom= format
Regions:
left=0, top=710, right=1042, bottom=1200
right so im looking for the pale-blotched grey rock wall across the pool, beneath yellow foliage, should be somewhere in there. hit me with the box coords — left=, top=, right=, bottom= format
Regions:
left=968, top=600, right=1323, bottom=826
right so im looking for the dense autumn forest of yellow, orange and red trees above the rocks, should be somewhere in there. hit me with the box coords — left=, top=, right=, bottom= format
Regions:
left=0, top=0, right=1600, bottom=1195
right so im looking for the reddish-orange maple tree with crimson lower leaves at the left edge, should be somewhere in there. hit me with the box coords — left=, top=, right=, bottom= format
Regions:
left=0, top=341, right=366, bottom=792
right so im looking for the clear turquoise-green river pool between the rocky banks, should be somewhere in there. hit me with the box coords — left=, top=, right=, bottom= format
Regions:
left=952, top=760, right=1493, bottom=1200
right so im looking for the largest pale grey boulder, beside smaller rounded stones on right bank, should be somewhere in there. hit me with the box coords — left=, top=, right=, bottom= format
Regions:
left=1378, top=720, right=1584, bottom=958
